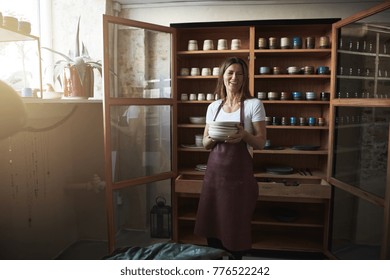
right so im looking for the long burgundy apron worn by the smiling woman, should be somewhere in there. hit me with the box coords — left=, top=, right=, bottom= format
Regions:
left=195, top=102, right=258, bottom=251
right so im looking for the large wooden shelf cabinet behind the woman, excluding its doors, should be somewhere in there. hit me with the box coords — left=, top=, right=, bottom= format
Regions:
left=173, top=19, right=337, bottom=252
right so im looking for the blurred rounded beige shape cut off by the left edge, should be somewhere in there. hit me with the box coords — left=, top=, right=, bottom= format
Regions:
left=0, top=81, right=27, bottom=140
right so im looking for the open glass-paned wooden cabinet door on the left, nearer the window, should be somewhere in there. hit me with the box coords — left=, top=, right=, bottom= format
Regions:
left=103, top=15, right=176, bottom=251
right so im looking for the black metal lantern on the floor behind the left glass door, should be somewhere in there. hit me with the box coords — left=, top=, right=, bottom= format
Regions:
left=150, top=196, right=172, bottom=238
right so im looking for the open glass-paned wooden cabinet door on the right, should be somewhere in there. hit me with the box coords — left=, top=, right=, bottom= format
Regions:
left=329, top=2, right=390, bottom=259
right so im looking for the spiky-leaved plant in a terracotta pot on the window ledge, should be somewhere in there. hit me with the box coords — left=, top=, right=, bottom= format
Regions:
left=42, top=17, right=102, bottom=98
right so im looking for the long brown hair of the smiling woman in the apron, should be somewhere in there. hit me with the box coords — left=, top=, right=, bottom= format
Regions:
left=215, top=57, right=252, bottom=101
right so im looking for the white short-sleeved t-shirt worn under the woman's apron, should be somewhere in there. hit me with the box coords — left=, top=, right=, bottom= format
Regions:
left=206, top=98, right=265, bottom=133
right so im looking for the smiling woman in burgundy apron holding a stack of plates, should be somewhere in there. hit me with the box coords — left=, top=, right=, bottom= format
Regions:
left=195, top=57, right=266, bottom=258
